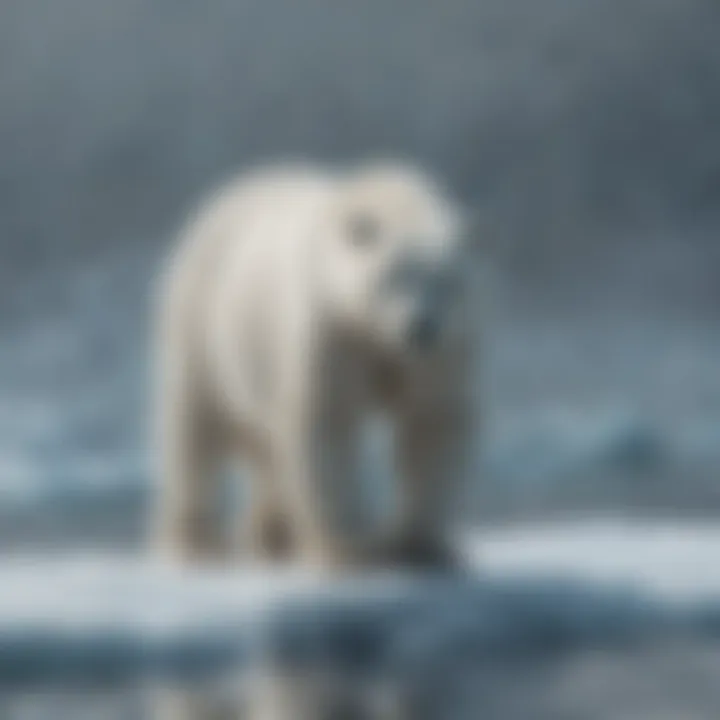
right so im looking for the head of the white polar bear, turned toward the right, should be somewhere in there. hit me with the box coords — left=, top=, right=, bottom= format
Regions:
left=318, top=163, right=473, bottom=358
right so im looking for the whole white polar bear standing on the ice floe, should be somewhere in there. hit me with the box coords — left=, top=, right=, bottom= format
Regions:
left=154, top=161, right=479, bottom=568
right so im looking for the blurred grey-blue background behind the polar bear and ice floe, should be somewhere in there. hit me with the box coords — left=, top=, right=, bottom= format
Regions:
left=0, top=0, right=720, bottom=717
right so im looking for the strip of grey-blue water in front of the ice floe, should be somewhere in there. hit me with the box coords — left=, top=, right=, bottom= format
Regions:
left=7, top=641, right=720, bottom=720
